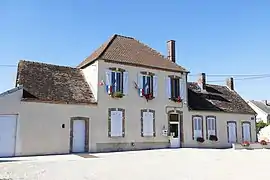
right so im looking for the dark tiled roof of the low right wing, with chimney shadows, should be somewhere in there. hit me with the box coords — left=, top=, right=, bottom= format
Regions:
left=188, top=82, right=256, bottom=114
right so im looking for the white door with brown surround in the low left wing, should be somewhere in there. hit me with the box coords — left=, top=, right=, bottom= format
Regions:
left=72, top=120, right=85, bottom=152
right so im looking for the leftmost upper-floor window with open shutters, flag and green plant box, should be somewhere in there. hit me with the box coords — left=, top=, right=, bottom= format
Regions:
left=106, top=68, right=128, bottom=95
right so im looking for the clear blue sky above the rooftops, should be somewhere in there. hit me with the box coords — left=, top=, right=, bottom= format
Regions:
left=0, top=0, right=270, bottom=99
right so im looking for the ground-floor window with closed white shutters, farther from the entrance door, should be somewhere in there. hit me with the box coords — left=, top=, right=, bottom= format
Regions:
left=108, top=108, right=125, bottom=137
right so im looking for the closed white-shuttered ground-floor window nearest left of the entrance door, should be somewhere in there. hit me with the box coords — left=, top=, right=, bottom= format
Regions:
left=141, top=109, right=156, bottom=137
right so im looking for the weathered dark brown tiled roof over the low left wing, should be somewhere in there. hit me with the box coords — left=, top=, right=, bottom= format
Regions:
left=17, top=61, right=94, bottom=103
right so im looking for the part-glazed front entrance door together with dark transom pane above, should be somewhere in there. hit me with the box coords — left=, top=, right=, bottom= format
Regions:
left=169, top=114, right=180, bottom=148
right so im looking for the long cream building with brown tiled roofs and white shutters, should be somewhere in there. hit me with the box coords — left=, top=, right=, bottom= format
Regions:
left=0, top=35, right=255, bottom=156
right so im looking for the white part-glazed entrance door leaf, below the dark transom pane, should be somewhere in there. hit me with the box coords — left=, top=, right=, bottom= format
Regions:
left=170, top=122, right=180, bottom=148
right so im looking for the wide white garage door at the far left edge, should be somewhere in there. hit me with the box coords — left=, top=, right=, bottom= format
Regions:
left=0, top=115, right=17, bottom=157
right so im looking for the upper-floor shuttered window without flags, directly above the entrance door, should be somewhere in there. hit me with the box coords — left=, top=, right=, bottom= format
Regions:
left=166, top=76, right=184, bottom=99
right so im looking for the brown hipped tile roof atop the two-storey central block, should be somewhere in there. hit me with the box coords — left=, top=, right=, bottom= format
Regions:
left=78, top=35, right=187, bottom=72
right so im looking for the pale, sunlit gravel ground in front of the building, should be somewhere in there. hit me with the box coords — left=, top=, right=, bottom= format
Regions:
left=0, top=149, right=270, bottom=180
